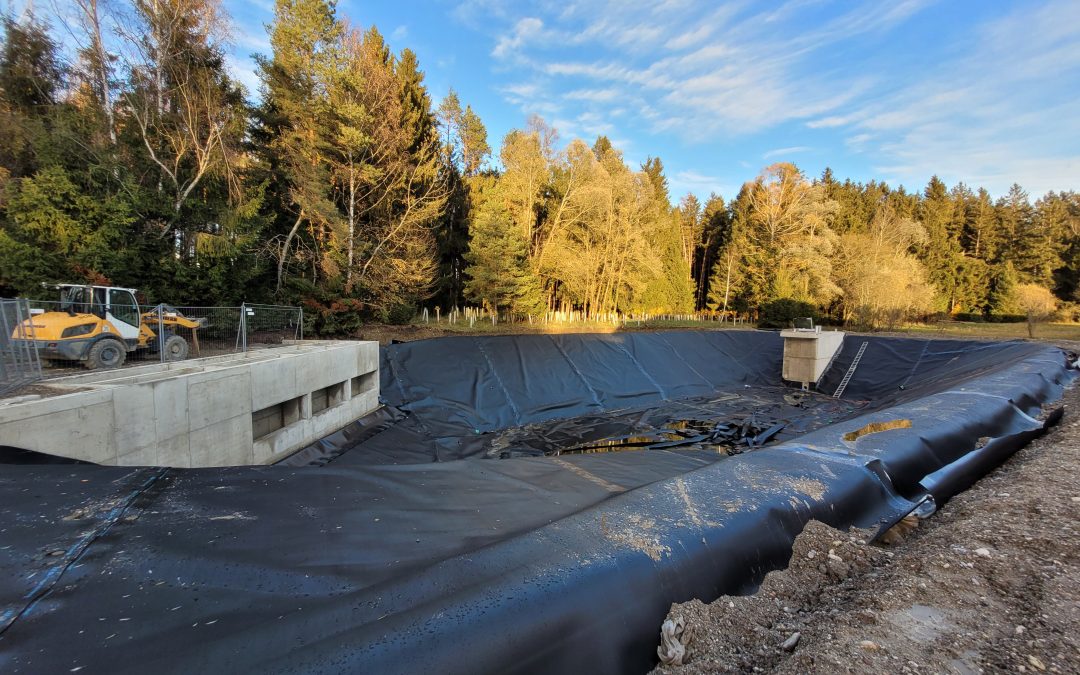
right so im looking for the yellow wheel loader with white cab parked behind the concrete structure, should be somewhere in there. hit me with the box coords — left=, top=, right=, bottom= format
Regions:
left=12, top=284, right=205, bottom=368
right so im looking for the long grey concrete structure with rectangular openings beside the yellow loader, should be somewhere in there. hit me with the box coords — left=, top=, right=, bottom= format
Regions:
left=0, top=341, right=379, bottom=467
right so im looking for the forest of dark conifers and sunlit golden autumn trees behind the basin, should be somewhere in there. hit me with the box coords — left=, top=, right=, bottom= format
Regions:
left=0, top=0, right=1080, bottom=335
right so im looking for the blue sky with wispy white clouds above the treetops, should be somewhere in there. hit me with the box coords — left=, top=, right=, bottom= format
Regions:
left=143, top=0, right=1080, bottom=199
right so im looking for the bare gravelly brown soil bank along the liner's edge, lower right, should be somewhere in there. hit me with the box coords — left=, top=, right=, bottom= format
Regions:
left=658, top=387, right=1080, bottom=674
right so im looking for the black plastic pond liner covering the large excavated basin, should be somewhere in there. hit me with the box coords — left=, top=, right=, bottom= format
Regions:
left=0, top=332, right=1074, bottom=673
